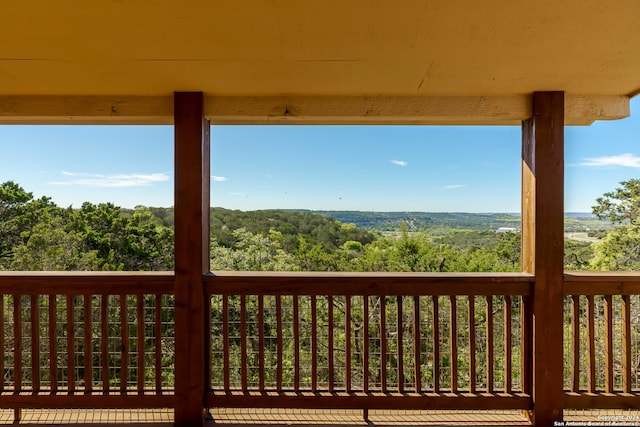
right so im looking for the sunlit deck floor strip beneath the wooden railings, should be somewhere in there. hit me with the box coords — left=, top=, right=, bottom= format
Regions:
left=0, top=409, right=640, bottom=427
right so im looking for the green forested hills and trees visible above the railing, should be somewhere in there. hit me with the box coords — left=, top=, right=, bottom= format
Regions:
left=0, top=180, right=640, bottom=272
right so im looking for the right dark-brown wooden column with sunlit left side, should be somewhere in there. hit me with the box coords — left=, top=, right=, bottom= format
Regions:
left=522, top=92, right=564, bottom=426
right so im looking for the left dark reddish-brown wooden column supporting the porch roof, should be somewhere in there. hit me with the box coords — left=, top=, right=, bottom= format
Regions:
left=174, top=92, right=210, bottom=426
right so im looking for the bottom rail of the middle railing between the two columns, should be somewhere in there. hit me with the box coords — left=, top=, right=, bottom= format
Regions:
left=206, top=392, right=532, bottom=410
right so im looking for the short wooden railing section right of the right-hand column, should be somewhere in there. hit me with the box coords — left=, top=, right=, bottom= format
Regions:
left=564, top=272, right=640, bottom=409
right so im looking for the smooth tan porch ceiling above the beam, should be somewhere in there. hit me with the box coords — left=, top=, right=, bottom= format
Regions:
left=0, top=0, right=640, bottom=96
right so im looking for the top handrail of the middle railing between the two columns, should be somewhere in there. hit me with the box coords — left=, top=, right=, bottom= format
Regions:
left=203, top=271, right=534, bottom=296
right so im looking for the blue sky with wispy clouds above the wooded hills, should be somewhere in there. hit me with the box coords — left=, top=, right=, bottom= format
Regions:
left=0, top=98, right=640, bottom=212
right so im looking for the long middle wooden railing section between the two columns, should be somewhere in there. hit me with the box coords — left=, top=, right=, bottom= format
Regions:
left=205, top=273, right=533, bottom=409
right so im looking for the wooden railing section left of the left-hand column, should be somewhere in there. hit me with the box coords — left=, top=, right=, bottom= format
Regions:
left=0, top=273, right=174, bottom=409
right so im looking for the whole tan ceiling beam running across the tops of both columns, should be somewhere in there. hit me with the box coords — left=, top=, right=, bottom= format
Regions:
left=0, top=95, right=629, bottom=125
